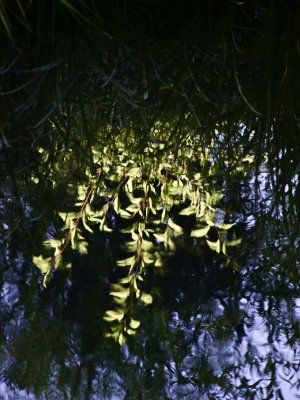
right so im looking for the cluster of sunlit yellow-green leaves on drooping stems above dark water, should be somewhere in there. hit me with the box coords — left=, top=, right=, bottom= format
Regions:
left=33, top=140, right=251, bottom=344
